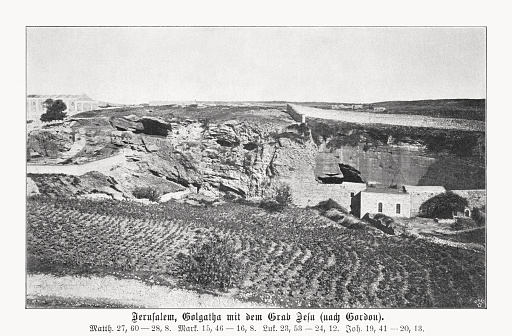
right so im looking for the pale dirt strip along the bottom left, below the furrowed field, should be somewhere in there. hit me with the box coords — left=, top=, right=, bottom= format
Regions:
left=27, top=274, right=270, bottom=308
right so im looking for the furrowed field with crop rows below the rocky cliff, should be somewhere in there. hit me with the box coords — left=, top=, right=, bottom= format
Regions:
left=27, top=197, right=486, bottom=308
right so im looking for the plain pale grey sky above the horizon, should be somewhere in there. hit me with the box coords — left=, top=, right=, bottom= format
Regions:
left=26, top=27, right=486, bottom=103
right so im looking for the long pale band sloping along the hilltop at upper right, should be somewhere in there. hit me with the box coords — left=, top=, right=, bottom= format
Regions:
left=290, top=104, right=485, bottom=132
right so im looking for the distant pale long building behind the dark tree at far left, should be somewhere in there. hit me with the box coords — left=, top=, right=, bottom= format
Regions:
left=27, top=94, right=99, bottom=121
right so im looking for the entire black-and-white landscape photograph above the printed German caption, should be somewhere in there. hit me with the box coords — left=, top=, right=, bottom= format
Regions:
left=24, top=26, right=488, bottom=310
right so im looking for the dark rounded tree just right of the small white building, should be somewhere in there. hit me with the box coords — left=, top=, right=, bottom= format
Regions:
left=420, top=191, right=468, bottom=218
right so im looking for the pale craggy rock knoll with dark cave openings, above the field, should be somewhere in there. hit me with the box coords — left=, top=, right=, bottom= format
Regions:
left=29, top=116, right=317, bottom=202
